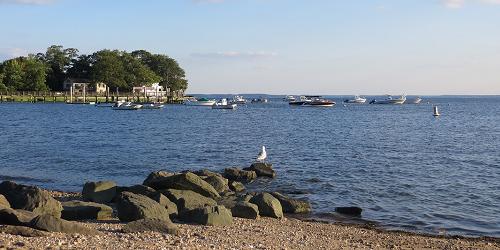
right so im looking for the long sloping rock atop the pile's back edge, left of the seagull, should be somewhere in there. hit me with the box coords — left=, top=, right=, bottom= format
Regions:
left=144, top=172, right=219, bottom=198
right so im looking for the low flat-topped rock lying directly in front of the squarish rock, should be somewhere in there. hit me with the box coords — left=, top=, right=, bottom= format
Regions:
left=61, top=201, right=113, bottom=220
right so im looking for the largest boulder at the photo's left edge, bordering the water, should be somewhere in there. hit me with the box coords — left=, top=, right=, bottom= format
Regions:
left=0, top=181, right=62, bottom=217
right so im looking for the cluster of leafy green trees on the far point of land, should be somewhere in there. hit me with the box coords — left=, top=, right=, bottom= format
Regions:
left=0, top=45, right=188, bottom=91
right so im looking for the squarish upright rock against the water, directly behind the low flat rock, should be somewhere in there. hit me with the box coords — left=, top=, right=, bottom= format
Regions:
left=82, top=181, right=116, bottom=203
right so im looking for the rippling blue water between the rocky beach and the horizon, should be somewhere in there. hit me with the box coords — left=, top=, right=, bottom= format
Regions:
left=0, top=97, right=500, bottom=237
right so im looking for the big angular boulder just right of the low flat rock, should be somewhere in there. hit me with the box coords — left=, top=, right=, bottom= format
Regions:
left=116, top=192, right=170, bottom=221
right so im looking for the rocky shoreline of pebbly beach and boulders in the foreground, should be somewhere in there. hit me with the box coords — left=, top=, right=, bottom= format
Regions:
left=0, top=163, right=500, bottom=249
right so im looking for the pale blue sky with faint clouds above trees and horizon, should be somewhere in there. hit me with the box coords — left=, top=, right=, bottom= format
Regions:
left=0, top=0, right=500, bottom=95
